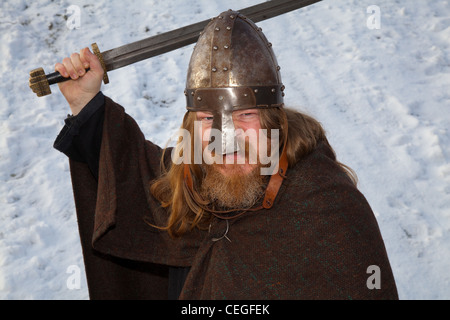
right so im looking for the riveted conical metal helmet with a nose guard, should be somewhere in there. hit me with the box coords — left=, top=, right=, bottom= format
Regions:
left=185, top=10, right=284, bottom=154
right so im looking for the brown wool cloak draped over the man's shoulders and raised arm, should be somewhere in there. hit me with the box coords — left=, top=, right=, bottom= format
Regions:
left=71, top=98, right=398, bottom=299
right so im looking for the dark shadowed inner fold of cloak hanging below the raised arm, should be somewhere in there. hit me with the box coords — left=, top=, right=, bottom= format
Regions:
left=70, top=161, right=168, bottom=300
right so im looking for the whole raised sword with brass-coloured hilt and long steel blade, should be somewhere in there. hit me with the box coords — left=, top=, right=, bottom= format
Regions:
left=29, top=0, right=321, bottom=97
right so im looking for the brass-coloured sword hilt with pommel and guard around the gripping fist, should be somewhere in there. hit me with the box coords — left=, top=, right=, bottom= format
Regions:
left=29, top=43, right=109, bottom=97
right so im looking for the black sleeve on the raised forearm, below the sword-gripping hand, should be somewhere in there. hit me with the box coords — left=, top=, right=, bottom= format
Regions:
left=53, top=92, right=105, bottom=179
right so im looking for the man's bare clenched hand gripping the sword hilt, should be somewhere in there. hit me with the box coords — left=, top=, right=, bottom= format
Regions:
left=55, top=48, right=104, bottom=115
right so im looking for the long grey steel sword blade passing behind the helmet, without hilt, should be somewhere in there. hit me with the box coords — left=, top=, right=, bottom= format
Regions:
left=102, top=0, right=321, bottom=71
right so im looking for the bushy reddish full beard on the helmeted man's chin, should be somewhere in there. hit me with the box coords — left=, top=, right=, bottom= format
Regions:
left=200, top=164, right=267, bottom=210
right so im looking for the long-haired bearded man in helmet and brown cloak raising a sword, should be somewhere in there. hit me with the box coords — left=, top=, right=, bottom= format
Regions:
left=55, top=11, right=397, bottom=299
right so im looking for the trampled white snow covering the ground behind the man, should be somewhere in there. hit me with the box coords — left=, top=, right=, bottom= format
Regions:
left=0, top=0, right=450, bottom=300
